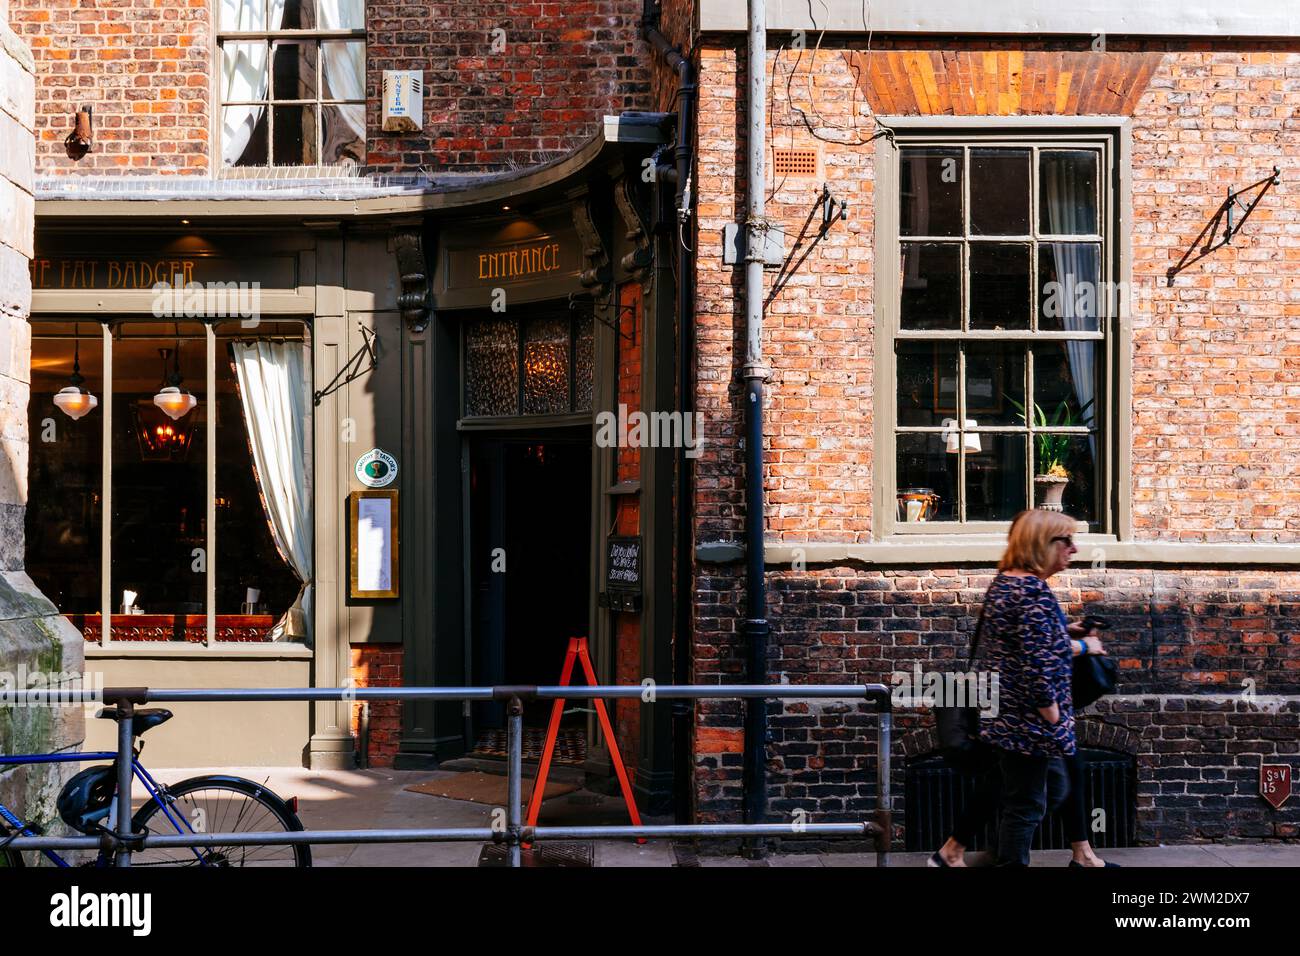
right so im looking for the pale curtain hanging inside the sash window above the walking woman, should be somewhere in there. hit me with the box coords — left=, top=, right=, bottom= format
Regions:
left=1039, top=163, right=1104, bottom=460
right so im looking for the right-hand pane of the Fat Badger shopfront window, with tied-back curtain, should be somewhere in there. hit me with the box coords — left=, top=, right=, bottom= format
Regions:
left=216, top=324, right=312, bottom=641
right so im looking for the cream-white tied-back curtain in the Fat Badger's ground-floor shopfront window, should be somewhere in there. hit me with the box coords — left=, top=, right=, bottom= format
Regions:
left=230, top=342, right=312, bottom=641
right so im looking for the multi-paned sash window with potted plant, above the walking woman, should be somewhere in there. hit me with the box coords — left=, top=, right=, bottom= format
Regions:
left=881, top=138, right=1117, bottom=531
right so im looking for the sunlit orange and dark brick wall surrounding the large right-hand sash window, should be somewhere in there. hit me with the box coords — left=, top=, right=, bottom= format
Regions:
left=693, top=36, right=1300, bottom=840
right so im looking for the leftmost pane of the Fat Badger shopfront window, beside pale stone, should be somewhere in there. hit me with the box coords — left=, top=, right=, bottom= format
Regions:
left=26, top=323, right=104, bottom=616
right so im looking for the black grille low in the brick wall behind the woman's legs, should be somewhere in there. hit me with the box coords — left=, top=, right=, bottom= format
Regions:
left=904, top=749, right=1138, bottom=851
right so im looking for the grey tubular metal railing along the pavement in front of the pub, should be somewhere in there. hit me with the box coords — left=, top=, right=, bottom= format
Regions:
left=0, top=684, right=892, bottom=866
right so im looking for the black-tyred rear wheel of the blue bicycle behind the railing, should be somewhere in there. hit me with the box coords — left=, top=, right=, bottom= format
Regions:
left=131, top=774, right=312, bottom=866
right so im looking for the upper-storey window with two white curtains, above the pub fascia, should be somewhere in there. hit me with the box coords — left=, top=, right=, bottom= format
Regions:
left=217, top=0, right=365, bottom=166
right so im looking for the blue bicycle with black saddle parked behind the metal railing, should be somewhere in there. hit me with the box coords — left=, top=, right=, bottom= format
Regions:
left=0, top=708, right=312, bottom=869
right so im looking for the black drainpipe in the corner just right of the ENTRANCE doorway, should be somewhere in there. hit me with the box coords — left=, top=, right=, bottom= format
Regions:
left=641, top=0, right=699, bottom=823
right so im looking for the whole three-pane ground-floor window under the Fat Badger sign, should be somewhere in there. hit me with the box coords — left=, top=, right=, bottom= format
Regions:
left=26, top=319, right=312, bottom=644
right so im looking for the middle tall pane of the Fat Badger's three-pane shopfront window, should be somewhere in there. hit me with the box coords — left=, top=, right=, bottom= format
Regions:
left=111, top=321, right=211, bottom=640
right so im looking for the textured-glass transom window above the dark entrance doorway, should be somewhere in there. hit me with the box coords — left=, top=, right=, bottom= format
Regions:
left=463, top=311, right=593, bottom=419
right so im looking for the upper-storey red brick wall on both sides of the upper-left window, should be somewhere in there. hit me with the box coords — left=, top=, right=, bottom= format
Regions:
left=12, top=0, right=650, bottom=174
